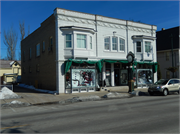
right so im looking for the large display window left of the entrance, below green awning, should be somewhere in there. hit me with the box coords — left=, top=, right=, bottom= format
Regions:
left=72, top=69, right=95, bottom=88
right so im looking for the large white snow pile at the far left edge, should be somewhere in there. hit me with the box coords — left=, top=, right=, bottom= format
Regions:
left=0, top=87, right=21, bottom=99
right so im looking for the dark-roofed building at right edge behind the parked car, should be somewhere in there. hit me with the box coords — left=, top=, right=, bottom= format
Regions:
left=156, top=26, right=180, bottom=79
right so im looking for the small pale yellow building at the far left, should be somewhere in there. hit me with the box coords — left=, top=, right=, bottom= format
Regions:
left=0, top=60, right=21, bottom=84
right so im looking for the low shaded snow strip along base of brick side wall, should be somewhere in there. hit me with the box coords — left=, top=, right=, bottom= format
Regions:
left=18, top=84, right=57, bottom=94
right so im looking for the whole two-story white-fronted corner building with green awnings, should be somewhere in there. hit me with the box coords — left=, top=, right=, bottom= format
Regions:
left=21, top=8, right=157, bottom=93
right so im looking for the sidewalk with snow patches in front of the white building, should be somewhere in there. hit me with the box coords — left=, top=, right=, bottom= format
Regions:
left=1, top=86, right=148, bottom=107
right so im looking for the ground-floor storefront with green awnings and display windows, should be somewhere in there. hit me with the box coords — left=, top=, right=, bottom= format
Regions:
left=65, top=59, right=157, bottom=93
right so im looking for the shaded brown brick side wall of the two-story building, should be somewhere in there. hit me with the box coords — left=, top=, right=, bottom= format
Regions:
left=21, top=15, right=56, bottom=90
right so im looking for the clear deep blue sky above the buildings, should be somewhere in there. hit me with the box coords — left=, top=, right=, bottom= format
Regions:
left=0, top=0, right=180, bottom=59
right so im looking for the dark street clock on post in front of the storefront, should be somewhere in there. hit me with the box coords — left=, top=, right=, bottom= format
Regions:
left=126, top=51, right=135, bottom=92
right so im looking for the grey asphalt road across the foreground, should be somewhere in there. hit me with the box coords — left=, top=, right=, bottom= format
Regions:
left=1, top=95, right=179, bottom=133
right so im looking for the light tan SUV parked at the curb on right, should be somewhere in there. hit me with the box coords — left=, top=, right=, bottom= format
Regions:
left=148, top=78, right=180, bottom=96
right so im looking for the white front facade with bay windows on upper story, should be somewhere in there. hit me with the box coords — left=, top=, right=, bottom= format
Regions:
left=54, top=8, right=157, bottom=93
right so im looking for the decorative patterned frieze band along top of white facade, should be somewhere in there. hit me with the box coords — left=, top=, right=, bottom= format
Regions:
left=58, top=15, right=156, bottom=34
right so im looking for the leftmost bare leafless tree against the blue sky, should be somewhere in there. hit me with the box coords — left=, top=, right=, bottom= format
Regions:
left=3, top=26, right=18, bottom=60
